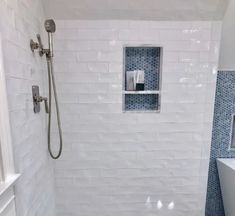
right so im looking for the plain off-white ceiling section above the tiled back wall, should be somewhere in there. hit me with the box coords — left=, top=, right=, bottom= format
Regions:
left=44, top=0, right=230, bottom=20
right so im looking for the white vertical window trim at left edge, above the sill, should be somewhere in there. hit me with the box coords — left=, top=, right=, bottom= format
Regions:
left=0, top=35, right=15, bottom=181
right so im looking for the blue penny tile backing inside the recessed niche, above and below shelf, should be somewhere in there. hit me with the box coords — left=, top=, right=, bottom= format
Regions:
left=124, top=47, right=161, bottom=111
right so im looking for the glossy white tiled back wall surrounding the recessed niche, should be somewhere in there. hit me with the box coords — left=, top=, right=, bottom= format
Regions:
left=55, top=20, right=221, bottom=216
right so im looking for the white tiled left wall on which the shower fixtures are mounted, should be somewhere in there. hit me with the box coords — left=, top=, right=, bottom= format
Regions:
left=0, top=0, right=55, bottom=216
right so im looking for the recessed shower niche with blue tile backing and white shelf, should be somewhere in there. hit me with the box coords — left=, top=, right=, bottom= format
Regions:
left=123, top=45, right=162, bottom=112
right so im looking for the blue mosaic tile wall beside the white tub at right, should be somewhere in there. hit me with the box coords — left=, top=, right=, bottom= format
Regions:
left=205, top=71, right=235, bottom=216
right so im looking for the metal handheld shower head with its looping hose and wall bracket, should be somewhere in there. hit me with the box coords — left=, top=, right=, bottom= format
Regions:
left=30, top=19, right=63, bottom=159
